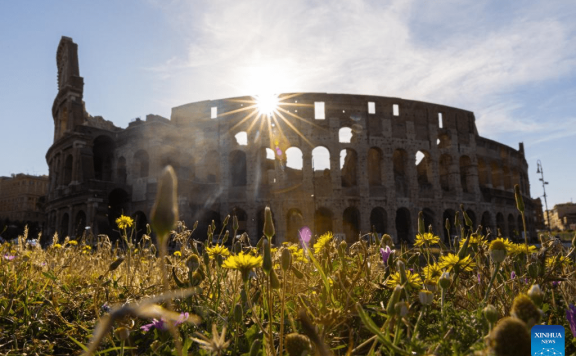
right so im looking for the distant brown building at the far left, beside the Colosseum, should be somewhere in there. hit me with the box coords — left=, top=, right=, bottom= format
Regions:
left=0, top=174, right=48, bottom=225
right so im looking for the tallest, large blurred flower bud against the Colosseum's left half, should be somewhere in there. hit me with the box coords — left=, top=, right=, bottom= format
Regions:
left=150, top=166, right=178, bottom=239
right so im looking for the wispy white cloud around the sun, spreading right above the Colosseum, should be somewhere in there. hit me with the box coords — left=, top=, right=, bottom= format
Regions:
left=147, top=0, right=576, bottom=139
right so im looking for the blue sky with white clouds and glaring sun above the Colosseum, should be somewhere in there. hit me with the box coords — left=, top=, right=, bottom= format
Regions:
left=0, top=0, right=576, bottom=207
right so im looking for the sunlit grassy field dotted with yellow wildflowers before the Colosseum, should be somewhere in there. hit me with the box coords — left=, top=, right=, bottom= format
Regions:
left=0, top=171, right=576, bottom=356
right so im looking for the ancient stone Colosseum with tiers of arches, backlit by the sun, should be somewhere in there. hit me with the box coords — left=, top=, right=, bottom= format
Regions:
left=46, top=37, right=535, bottom=246
